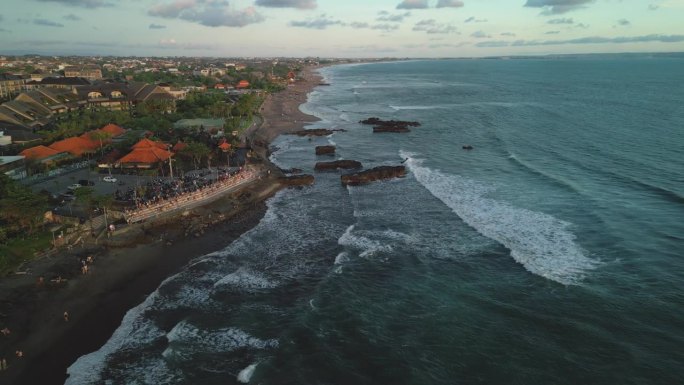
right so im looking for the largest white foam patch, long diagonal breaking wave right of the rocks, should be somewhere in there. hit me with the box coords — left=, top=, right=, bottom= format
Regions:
left=400, top=151, right=597, bottom=285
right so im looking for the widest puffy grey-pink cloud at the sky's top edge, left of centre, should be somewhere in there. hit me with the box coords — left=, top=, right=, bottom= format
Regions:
left=147, top=0, right=265, bottom=27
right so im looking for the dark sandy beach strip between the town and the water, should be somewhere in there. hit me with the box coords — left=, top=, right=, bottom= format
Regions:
left=0, top=67, right=321, bottom=384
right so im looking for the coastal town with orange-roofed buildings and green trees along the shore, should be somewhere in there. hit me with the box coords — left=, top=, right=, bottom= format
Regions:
left=0, top=56, right=384, bottom=274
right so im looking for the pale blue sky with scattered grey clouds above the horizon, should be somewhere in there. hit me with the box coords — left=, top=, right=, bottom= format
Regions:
left=0, top=0, right=684, bottom=57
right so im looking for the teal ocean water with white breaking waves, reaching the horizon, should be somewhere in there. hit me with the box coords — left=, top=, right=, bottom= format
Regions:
left=67, top=55, right=684, bottom=385
